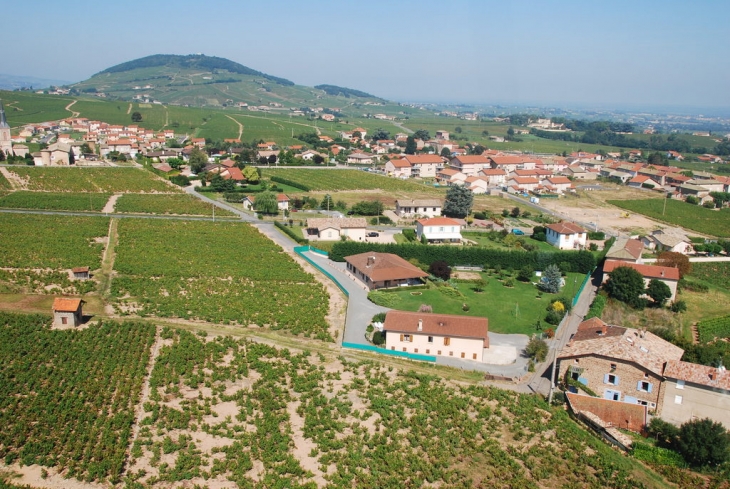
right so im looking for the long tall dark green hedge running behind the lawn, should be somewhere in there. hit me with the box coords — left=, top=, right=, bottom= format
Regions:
left=329, top=241, right=596, bottom=273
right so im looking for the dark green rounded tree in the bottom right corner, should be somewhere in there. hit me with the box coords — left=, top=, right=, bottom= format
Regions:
left=677, top=418, right=730, bottom=467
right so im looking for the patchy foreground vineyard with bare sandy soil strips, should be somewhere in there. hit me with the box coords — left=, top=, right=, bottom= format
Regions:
left=118, top=329, right=662, bottom=489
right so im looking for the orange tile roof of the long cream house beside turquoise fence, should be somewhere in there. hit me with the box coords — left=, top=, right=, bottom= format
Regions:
left=383, top=311, right=489, bottom=348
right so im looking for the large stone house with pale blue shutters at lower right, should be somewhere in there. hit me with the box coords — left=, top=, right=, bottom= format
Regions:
left=558, top=318, right=684, bottom=414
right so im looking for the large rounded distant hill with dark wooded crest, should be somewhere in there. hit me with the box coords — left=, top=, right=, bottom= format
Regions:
left=70, top=54, right=381, bottom=111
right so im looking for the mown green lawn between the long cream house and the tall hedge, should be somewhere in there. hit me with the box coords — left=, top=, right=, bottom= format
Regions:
left=387, top=273, right=584, bottom=335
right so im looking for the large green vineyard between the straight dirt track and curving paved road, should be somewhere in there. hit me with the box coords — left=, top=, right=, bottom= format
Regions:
left=112, top=219, right=332, bottom=341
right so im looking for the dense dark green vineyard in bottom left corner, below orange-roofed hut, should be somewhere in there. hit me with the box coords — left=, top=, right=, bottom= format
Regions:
left=0, top=313, right=155, bottom=481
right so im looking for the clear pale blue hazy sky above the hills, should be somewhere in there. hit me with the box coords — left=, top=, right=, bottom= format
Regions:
left=7, top=0, right=730, bottom=107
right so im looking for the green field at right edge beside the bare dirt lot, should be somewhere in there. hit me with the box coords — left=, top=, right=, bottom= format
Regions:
left=607, top=199, right=730, bottom=238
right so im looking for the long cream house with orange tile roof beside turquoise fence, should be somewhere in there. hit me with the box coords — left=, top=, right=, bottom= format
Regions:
left=383, top=311, right=489, bottom=362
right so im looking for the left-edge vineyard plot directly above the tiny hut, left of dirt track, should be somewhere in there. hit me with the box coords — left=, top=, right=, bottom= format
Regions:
left=0, top=214, right=109, bottom=270
